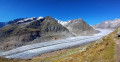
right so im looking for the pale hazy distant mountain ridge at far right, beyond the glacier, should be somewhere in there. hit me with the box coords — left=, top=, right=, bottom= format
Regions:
left=93, top=19, right=120, bottom=29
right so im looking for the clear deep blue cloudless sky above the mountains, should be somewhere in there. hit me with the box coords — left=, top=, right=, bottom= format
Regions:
left=0, top=0, right=120, bottom=25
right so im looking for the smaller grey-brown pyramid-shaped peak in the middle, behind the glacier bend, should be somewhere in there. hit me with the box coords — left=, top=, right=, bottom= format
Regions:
left=66, top=18, right=98, bottom=35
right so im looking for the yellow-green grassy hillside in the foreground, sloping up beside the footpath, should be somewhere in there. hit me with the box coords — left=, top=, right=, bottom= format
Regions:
left=0, top=28, right=117, bottom=62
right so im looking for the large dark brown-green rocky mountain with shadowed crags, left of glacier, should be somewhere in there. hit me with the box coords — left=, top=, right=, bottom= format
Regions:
left=0, top=16, right=72, bottom=50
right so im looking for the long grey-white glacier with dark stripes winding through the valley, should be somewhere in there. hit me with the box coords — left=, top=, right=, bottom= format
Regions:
left=0, top=29, right=113, bottom=59
